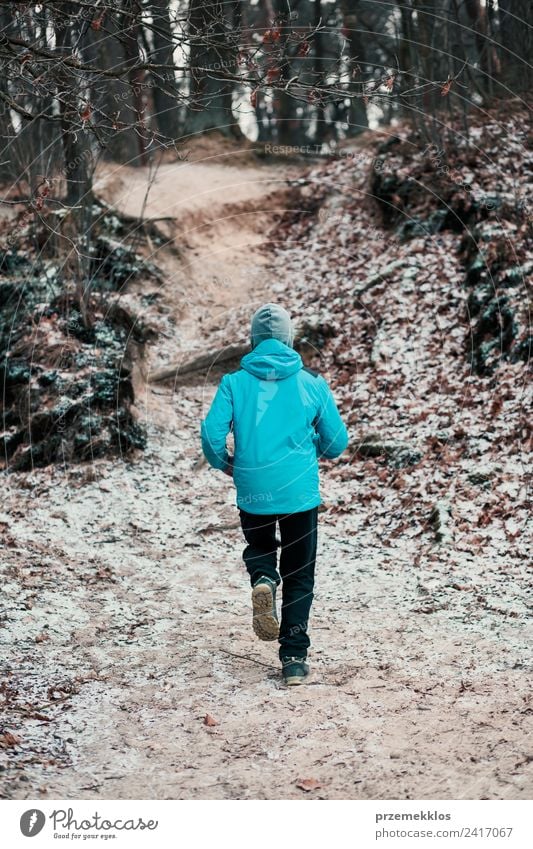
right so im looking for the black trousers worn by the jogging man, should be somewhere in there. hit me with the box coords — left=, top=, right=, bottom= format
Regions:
left=239, top=507, right=318, bottom=658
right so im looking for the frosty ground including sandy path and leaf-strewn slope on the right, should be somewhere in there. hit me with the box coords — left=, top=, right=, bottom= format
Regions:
left=0, top=117, right=533, bottom=799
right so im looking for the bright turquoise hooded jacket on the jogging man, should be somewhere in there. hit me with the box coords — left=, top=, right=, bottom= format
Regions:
left=201, top=339, right=348, bottom=515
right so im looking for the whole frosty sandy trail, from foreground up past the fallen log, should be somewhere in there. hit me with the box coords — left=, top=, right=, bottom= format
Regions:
left=0, top=151, right=531, bottom=799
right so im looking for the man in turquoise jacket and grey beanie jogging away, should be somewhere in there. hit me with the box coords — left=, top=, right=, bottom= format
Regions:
left=201, top=304, right=348, bottom=686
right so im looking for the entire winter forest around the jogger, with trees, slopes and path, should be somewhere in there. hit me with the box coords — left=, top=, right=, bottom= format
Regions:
left=0, top=0, right=533, bottom=800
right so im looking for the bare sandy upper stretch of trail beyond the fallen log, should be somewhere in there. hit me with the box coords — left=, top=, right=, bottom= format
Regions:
left=96, top=154, right=298, bottom=358
